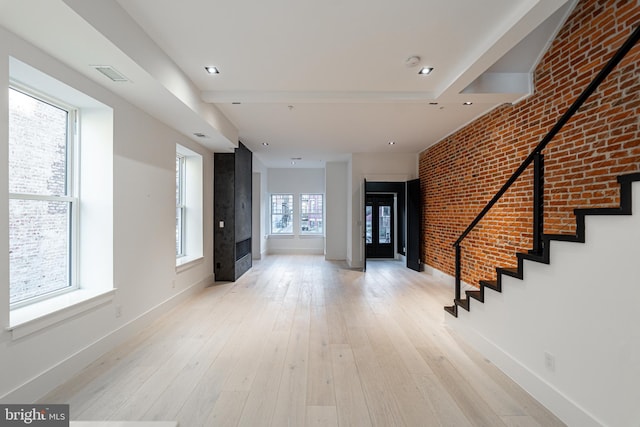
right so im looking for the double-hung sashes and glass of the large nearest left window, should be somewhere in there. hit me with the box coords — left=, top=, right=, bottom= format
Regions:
left=9, top=86, right=78, bottom=307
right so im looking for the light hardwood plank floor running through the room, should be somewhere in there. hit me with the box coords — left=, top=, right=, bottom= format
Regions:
left=42, top=256, right=563, bottom=427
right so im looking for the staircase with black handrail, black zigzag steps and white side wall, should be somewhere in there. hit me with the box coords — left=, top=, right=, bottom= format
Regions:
left=444, top=22, right=640, bottom=427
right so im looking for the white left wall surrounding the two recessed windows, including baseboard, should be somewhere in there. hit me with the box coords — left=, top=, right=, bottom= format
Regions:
left=0, top=28, right=213, bottom=403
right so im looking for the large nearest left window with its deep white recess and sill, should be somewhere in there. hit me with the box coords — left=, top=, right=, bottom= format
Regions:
left=4, top=57, right=115, bottom=339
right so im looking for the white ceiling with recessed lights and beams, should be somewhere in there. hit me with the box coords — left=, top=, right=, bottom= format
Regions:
left=0, top=0, right=575, bottom=167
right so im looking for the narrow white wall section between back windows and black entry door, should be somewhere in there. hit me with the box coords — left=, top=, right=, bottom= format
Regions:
left=325, top=162, right=349, bottom=260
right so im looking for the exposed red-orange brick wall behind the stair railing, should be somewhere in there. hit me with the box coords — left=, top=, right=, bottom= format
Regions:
left=420, top=0, right=640, bottom=285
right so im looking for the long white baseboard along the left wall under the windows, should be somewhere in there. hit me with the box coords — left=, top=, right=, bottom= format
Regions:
left=0, top=276, right=214, bottom=403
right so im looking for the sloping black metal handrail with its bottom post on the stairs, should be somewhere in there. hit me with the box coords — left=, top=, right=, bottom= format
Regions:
left=453, top=25, right=640, bottom=300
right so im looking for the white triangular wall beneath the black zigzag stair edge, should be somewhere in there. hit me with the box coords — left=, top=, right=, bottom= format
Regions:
left=446, top=183, right=640, bottom=426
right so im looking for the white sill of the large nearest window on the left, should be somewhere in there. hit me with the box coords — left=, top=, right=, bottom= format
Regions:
left=7, top=288, right=116, bottom=340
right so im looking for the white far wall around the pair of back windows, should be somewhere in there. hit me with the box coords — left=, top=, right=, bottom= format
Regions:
left=266, top=168, right=326, bottom=254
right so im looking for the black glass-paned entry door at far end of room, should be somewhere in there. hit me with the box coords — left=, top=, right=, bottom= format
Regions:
left=365, top=194, right=394, bottom=258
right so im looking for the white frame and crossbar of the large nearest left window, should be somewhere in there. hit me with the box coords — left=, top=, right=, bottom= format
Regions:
left=8, top=83, right=80, bottom=310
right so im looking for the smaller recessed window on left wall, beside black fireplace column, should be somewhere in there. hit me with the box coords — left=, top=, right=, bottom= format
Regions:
left=176, top=144, right=203, bottom=268
